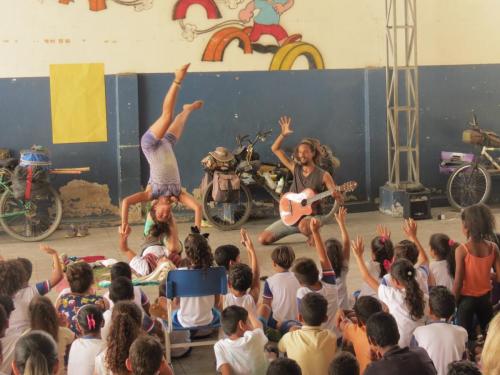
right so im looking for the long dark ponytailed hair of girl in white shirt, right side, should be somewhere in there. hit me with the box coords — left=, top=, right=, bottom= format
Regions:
left=391, top=259, right=425, bottom=320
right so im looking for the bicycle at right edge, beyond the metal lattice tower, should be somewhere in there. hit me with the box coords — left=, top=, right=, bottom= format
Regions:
left=446, top=113, right=500, bottom=210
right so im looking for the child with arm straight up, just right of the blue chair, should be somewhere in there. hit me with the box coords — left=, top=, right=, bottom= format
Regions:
left=224, top=228, right=260, bottom=312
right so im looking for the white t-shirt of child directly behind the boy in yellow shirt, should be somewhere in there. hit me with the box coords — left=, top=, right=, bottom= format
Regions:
left=262, top=271, right=300, bottom=322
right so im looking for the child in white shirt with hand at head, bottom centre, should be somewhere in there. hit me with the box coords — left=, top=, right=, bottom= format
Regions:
left=214, top=306, right=269, bottom=375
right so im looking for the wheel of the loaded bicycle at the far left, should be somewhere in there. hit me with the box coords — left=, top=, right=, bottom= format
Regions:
left=0, top=187, right=62, bottom=242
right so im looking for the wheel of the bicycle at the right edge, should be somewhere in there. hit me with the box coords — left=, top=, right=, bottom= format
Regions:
left=446, top=164, right=491, bottom=210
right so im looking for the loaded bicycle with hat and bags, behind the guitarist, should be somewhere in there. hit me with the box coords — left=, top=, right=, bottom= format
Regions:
left=201, top=130, right=340, bottom=230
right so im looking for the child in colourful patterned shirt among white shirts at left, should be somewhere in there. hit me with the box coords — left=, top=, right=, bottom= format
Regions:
left=56, top=262, right=108, bottom=336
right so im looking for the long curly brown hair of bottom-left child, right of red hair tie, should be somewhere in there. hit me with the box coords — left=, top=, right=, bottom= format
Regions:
left=105, top=301, right=142, bottom=374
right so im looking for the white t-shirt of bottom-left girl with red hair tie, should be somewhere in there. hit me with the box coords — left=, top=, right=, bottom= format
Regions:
left=68, top=338, right=106, bottom=375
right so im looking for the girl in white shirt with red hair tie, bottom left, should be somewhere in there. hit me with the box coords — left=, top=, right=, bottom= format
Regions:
left=68, top=305, right=106, bottom=375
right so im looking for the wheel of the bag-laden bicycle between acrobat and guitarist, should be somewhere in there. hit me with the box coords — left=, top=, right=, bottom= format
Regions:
left=203, top=181, right=252, bottom=230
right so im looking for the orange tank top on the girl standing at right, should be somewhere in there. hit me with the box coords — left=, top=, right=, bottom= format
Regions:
left=460, top=242, right=496, bottom=297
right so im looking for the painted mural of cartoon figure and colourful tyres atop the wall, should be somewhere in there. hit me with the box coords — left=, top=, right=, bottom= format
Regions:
left=172, top=0, right=325, bottom=70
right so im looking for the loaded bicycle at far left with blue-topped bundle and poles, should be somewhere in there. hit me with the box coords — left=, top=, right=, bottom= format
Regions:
left=0, top=146, right=89, bottom=242
